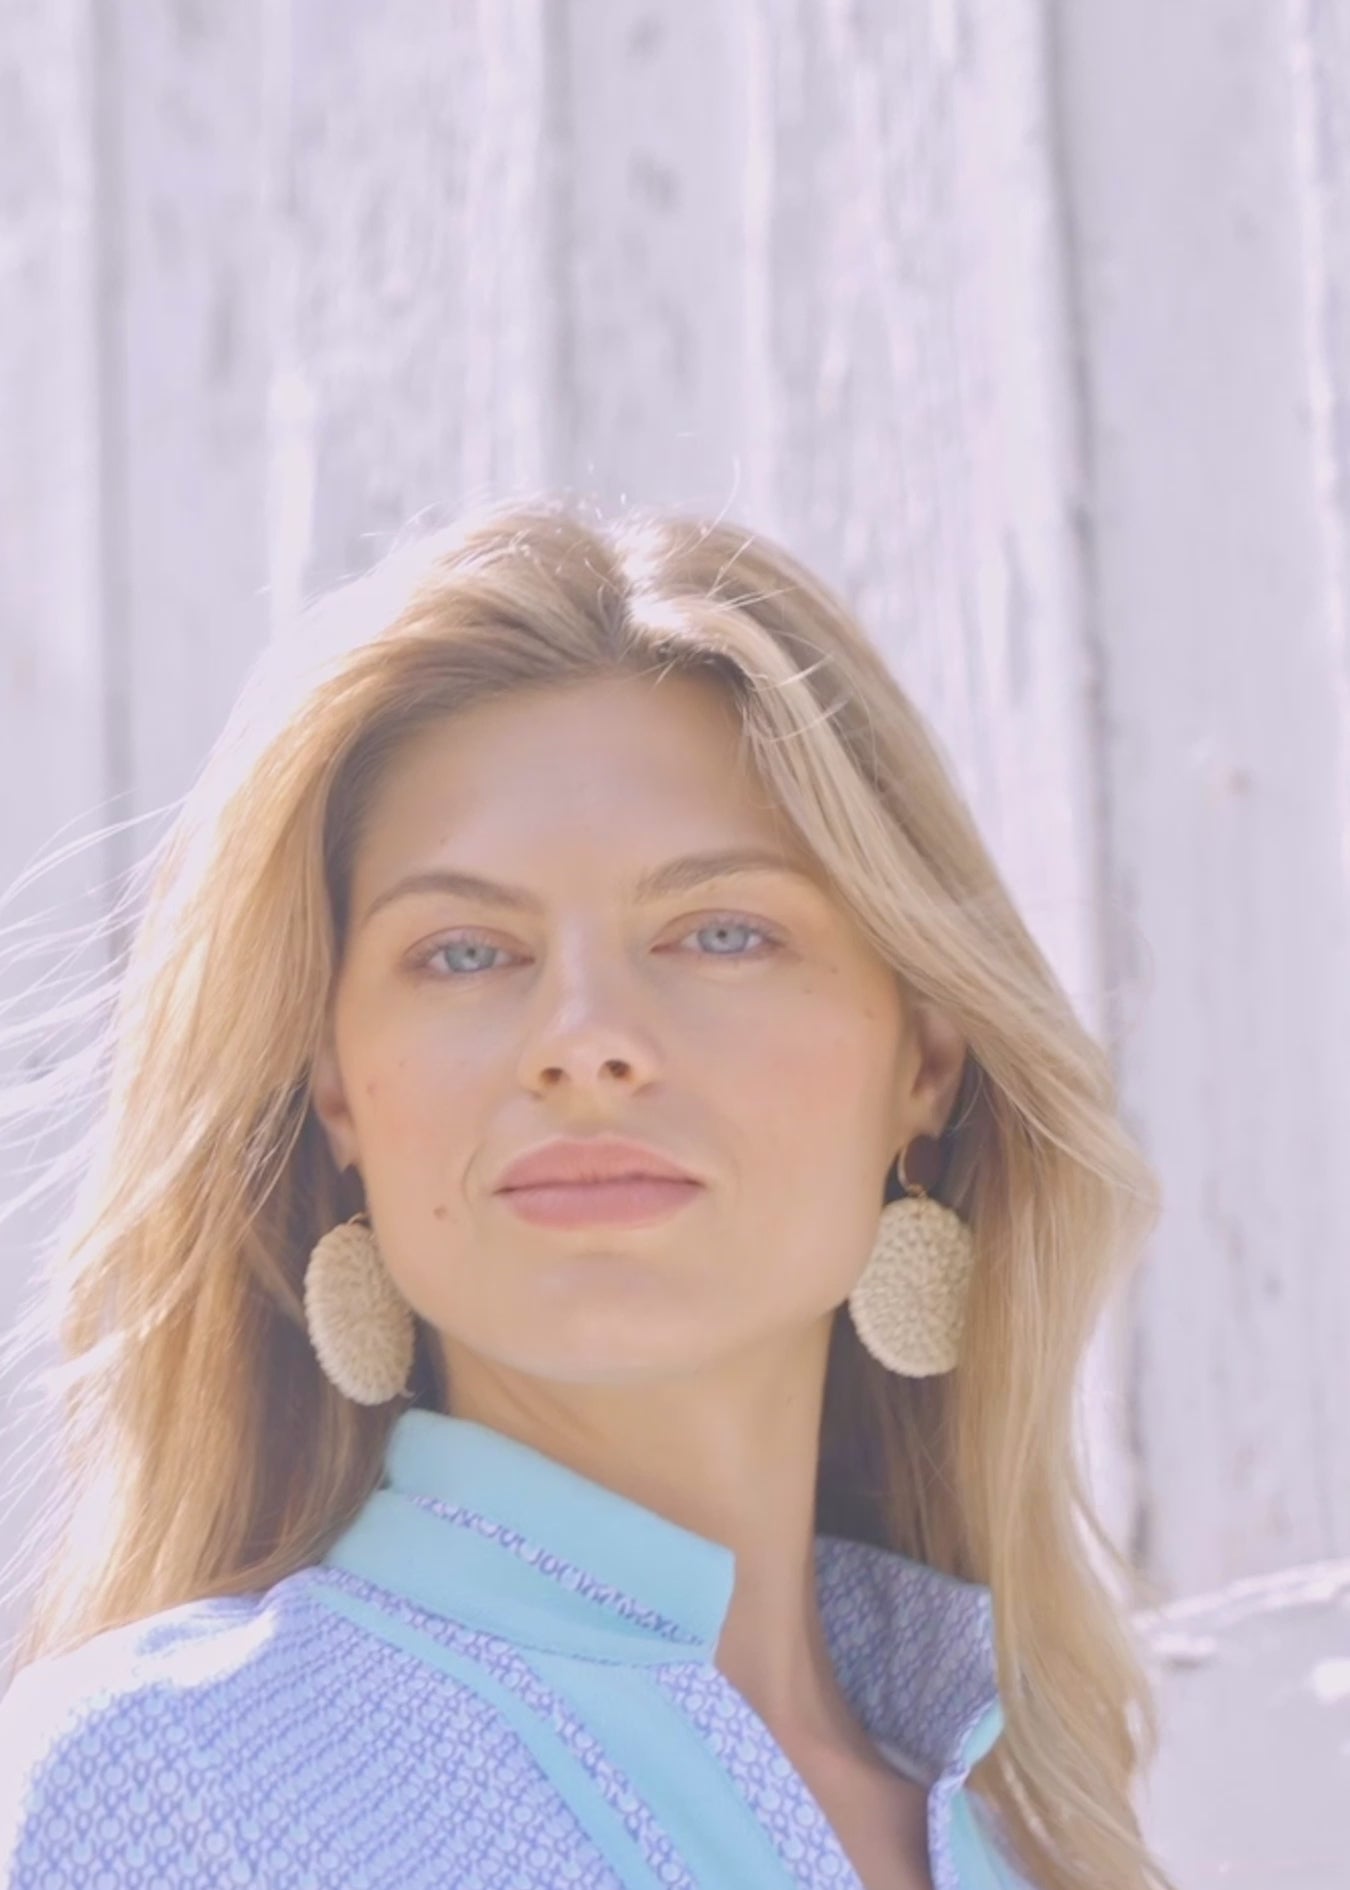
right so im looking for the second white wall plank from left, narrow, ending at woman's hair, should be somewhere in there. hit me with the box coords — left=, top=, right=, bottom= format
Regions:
left=102, top=0, right=270, bottom=827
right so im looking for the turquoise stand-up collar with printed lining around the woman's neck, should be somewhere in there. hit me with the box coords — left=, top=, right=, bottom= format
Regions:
left=323, top=1408, right=1002, bottom=1777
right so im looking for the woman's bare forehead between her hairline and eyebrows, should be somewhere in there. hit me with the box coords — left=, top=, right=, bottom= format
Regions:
left=357, top=671, right=811, bottom=875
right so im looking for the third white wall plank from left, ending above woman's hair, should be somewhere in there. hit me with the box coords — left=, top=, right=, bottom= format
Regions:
left=278, top=0, right=562, bottom=592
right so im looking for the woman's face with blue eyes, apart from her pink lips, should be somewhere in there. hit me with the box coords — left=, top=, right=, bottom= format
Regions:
left=314, top=673, right=964, bottom=1383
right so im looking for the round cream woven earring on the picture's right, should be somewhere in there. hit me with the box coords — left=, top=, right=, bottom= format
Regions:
left=849, top=1151, right=976, bottom=1378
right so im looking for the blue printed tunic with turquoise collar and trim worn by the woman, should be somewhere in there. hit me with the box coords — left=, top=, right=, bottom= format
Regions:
left=0, top=1410, right=1029, bottom=1890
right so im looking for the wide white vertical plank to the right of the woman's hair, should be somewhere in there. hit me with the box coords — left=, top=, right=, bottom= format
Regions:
left=1057, top=0, right=1350, bottom=1591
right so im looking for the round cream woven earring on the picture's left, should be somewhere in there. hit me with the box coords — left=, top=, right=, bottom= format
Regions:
left=304, top=1208, right=414, bottom=1404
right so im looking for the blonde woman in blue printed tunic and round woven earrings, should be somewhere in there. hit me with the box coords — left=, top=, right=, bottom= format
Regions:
left=0, top=501, right=1167, bottom=1890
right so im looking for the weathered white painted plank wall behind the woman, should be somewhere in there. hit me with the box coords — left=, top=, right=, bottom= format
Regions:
left=0, top=0, right=1350, bottom=1859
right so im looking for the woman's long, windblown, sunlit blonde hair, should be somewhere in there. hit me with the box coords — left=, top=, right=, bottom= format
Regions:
left=2, top=499, right=1170, bottom=1890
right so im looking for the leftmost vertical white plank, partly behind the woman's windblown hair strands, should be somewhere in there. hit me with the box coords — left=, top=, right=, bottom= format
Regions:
left=0, top=0, right=106, bottom=1661
